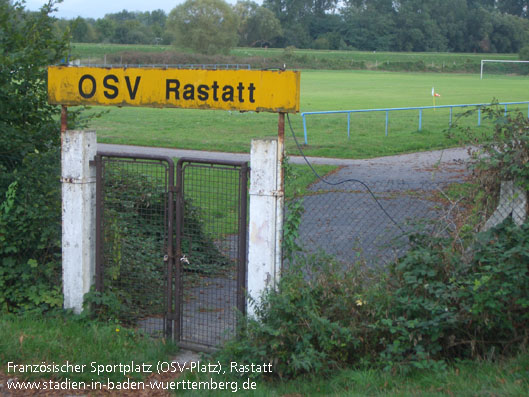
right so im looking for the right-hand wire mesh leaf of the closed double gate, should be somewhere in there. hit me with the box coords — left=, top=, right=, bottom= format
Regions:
left=175, top=159, right=248, bottom=347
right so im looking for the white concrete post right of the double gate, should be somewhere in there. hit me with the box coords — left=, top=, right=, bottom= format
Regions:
left=248, top=139, right=283, bottom=316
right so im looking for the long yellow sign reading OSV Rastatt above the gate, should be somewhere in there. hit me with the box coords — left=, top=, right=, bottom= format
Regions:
left=48, top=66, right=300, bottom=113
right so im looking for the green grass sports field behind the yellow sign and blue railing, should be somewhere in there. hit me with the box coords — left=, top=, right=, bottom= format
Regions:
left=86, top=71, right=529, bottom=158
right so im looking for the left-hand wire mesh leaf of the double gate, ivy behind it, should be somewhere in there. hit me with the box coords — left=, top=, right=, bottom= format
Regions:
left=92, top=153, right=174, bottom=336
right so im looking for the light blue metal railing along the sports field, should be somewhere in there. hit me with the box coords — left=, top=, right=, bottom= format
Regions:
left=301, top=101, right=529, bottom=145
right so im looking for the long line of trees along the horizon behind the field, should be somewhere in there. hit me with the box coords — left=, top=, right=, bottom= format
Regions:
left=57, top=0, right=529, bottom=53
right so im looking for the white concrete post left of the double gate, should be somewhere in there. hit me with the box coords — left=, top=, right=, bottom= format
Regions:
left=61, top=131, right=97, bottom=313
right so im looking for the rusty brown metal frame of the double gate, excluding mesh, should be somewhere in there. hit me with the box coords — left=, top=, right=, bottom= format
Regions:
left=93, top=151, right=249, bottom=351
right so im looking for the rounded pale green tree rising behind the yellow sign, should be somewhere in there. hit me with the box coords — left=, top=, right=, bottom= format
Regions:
left=167, top=0, right=239, bottom=54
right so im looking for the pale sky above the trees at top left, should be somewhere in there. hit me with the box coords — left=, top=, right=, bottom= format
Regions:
left=26, top=0, right=194, bottom=19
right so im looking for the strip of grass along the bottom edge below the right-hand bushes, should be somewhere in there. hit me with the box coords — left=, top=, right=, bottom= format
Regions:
left=173, top=352, right=529, bottom=397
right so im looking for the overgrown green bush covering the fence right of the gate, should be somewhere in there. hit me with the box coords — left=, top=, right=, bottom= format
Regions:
left=220, top=107, right=529, bottom=377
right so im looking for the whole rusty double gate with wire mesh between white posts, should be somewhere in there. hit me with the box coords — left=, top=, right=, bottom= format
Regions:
left=95, top=152, right=248, bottom=350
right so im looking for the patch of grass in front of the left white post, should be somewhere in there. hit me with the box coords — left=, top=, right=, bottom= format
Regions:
left=0, top=314, right=178, bottom=382
